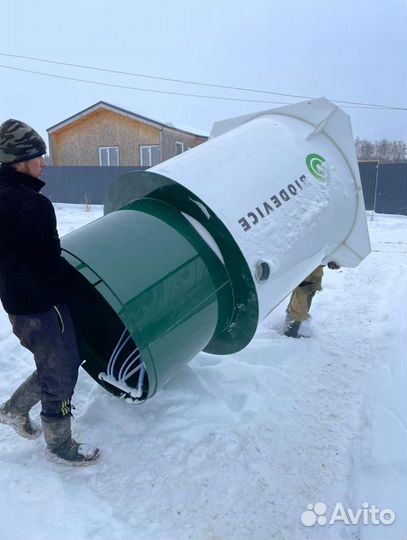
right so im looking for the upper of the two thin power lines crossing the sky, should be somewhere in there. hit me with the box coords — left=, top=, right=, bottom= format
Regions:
left=0, top=52, right=407, bottom=111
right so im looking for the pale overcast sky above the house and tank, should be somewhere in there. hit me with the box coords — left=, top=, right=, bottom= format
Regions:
left=0, top=0, right=407, bottom=146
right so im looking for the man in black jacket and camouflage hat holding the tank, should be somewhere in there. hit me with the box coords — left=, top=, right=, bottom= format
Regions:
left=0, top=119, right=99, bottom=465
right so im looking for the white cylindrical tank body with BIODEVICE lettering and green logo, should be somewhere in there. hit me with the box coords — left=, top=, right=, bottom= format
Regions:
left=148, top=98, right=370, bottom=320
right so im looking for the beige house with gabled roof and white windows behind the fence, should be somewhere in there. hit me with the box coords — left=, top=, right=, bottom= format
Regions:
left=47, top=101, right=208, bottom=167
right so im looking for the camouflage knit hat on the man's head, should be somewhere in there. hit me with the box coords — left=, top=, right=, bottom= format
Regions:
left=0, top=118, right=47, bottom=164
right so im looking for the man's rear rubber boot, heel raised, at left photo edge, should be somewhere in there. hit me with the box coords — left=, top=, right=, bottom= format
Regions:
left=0, top=371, right=41, bottom=439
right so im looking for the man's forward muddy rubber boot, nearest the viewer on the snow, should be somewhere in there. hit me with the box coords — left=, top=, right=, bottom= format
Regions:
left=41, top=414, right=99, bottom=466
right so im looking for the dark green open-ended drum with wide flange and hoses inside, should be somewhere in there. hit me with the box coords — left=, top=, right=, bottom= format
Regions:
left=61, top=173, right=257, bottom=402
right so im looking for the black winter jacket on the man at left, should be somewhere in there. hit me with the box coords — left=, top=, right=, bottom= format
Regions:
left=0, top=167, right=72, bottom=315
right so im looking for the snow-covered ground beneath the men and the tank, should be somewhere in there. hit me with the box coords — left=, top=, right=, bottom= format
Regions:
left=0, top=204, right=407, bottom=540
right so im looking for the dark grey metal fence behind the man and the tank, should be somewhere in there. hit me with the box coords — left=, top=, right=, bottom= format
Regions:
left=43, top=161, right=407, bottom=215
